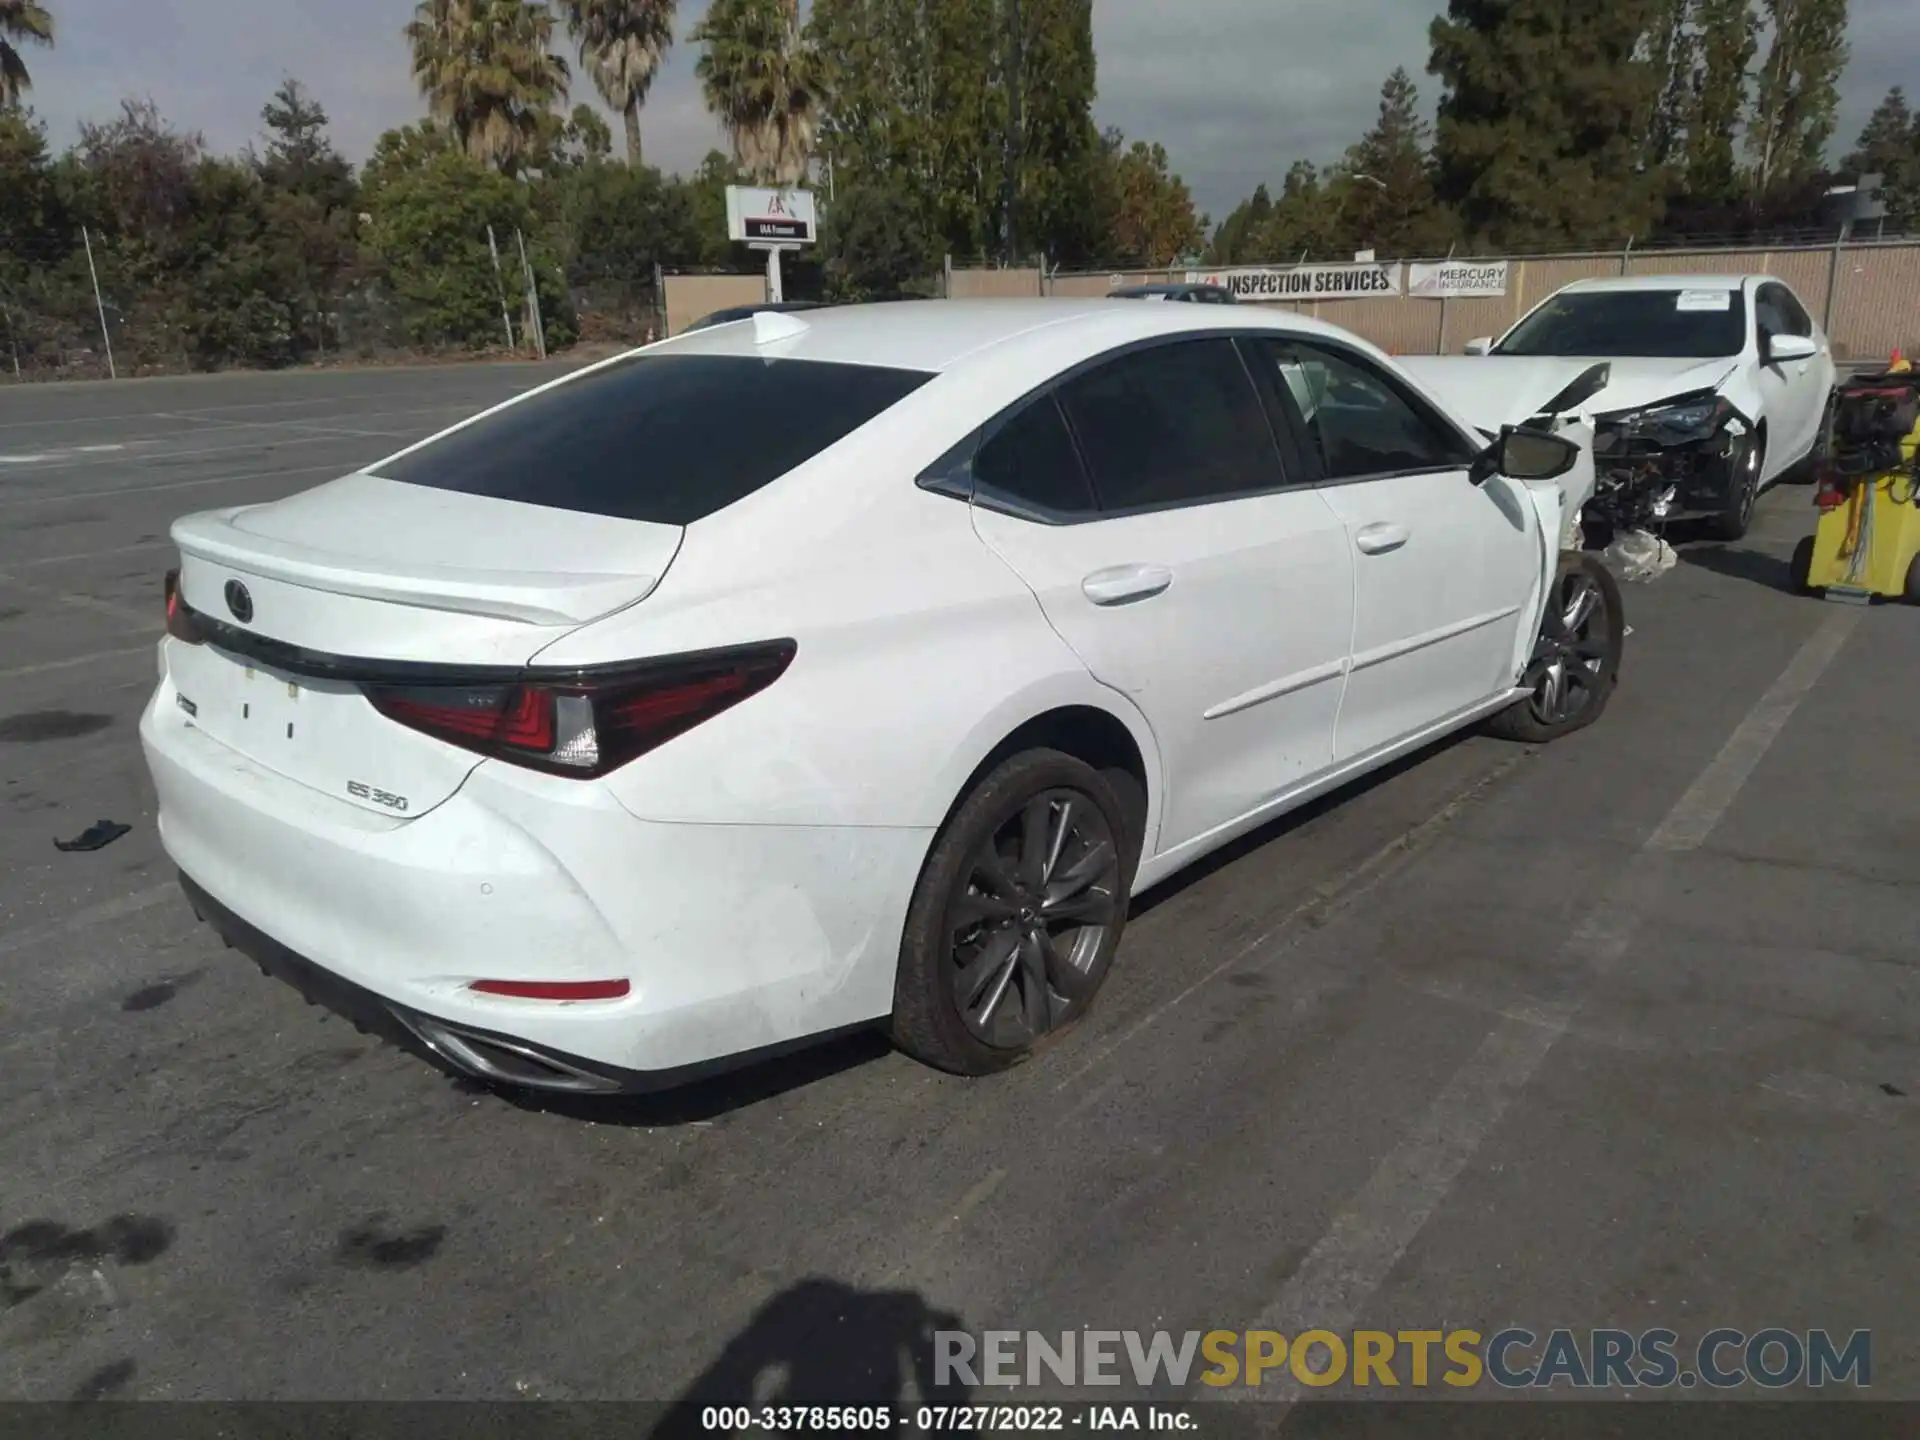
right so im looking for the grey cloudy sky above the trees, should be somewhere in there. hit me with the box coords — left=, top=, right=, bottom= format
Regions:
left=27, top=0, right=1920, bottom=221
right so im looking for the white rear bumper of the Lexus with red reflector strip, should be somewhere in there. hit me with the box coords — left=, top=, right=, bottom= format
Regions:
left=140, top=664, right=929, bottom=1091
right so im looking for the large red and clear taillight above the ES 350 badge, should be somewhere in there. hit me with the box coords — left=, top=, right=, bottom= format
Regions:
left=365, top=639, right=795, bottom=780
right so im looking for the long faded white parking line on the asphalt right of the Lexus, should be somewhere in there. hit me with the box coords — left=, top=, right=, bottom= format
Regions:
left=1229, top=609, right=1860, bottom=1423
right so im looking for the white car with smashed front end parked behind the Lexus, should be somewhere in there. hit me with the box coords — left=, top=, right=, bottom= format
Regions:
left=1417, top=275, right=1836, bottom=543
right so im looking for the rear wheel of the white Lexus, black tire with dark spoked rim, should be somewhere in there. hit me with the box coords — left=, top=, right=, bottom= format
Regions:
left=889, top=749, right=1146, bottom=1075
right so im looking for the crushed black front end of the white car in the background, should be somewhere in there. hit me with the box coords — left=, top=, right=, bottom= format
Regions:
left=1586, top=390, right=1753, bottom=545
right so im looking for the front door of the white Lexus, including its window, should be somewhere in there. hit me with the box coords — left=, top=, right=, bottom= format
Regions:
left=1254, top=340, right=1540, bottom=760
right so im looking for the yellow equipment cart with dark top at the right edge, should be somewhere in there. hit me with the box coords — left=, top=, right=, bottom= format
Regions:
left=1793, top=361, right=1920, bottom=605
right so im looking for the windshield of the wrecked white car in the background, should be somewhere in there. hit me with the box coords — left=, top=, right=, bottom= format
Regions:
left=1494, top=290, right=1747, bottom=359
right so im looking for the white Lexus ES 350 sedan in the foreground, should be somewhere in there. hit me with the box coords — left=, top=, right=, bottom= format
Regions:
left=140, top=300, right=1622, bottom=1091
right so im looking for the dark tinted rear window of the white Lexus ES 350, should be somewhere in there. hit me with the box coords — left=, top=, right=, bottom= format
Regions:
left=374, top=355, right=933, bottom=524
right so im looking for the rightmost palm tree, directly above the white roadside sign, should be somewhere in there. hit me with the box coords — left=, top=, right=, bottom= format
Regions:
left=693, top=0, right=820, bottom=184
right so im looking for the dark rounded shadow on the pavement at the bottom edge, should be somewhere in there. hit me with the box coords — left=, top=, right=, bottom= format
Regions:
left=653, top=1279, right=970, bottom=1440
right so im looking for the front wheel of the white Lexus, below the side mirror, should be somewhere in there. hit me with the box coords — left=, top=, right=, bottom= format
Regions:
left=1486, top=551, right=1626, bottom=745
